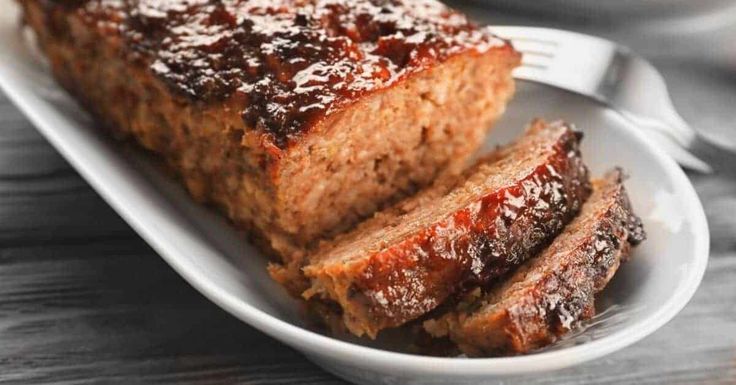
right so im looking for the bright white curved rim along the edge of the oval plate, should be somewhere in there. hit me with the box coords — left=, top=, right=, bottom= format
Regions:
left=0, top=7, right=710, bottom=377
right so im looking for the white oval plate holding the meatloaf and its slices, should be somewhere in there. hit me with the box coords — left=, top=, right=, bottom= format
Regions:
left=0, top=0, right=709, bottom=384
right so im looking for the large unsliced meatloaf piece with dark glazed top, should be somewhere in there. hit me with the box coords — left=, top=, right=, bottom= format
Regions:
left=18, top=0, right=520, bottom=261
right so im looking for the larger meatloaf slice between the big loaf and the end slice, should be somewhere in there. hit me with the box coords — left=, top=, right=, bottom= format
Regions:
left=303, top=121, right=590, bottom=337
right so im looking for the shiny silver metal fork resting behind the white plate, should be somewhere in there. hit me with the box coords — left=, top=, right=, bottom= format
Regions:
left=493, top=27, right=736, bottom=173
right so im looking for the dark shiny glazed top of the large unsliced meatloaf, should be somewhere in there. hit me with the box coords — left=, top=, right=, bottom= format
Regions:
left=37, top=0, right=513, bottom=149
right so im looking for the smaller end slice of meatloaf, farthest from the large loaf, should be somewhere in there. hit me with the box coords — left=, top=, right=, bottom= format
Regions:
left=424, top=170, right=645, bottom=355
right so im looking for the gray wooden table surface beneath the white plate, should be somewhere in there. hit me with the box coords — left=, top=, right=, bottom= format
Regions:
left=0, top=3, right=736, bottom=385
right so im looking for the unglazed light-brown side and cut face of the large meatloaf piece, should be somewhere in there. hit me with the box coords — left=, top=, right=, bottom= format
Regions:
left=20, top=0, right=519, bottom=262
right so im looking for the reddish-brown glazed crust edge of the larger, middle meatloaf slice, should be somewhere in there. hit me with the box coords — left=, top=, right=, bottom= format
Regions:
left=351, top=130, right=591, bottom=326
